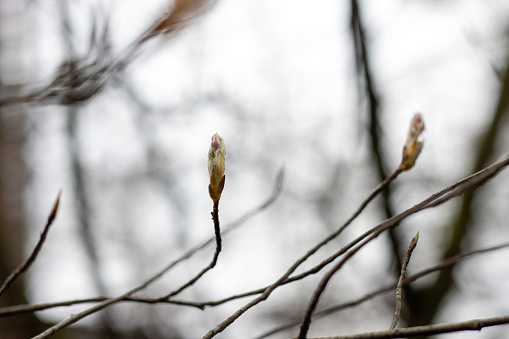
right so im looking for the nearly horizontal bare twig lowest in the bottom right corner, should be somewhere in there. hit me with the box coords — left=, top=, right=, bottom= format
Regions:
left=309, top=315, right=509, bottom=339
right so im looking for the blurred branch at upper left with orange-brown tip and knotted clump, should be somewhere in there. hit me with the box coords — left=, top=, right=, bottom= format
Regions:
left=0, top=0, right=215, bottom=106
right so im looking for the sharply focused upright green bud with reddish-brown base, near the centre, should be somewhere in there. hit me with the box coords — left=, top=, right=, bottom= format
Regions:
left=209, top=133, right=226, bottom=202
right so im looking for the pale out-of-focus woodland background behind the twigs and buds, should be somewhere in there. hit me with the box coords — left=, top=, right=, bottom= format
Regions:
left=0, top=0, right=509, bottom=339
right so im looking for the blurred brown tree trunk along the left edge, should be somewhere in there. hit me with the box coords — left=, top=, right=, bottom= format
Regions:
left=0, top=0, right=42, bottom=338
